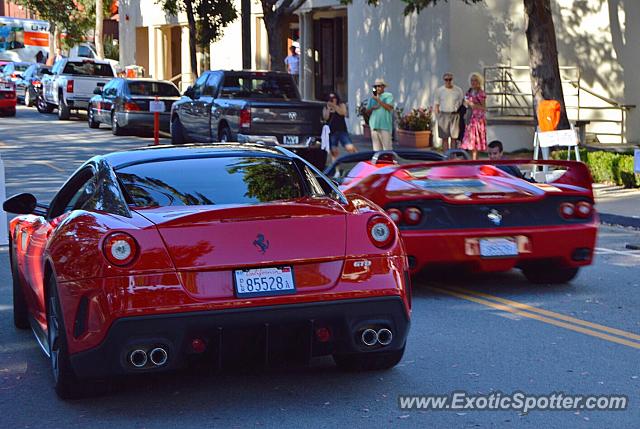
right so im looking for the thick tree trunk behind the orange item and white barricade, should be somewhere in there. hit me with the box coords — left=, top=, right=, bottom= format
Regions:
left=350, top=0, right=569, bottom=128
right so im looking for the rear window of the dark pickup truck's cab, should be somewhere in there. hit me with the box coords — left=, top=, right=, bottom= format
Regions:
left=221, top=75, right=298, bottom=100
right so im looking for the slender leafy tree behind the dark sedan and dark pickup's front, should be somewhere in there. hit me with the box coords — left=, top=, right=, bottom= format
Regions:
left=157, top=0, right=238, bottom=76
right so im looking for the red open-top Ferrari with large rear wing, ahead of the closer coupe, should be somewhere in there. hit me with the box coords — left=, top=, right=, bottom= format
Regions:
left=325, top=152, right=598, bottom=283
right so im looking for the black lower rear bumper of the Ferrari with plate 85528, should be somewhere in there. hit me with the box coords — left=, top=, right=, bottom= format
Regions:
left=71, top=296, right=410, bottom=377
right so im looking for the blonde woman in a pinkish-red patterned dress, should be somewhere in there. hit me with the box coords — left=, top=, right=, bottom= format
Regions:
left=460, top=73, right=487, bottom=159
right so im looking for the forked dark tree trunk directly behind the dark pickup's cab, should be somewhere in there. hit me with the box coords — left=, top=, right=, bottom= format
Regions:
left=260, top=0, right=306, bottom=71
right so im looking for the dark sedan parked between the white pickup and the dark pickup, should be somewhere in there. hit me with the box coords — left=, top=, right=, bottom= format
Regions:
left=87, top=78, right=180, bottom=135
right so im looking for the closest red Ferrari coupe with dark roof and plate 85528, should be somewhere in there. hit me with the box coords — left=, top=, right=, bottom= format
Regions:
left=3, top=143, right=411, bottom=398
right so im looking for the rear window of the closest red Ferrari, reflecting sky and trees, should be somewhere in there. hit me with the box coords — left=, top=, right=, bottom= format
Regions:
left=116, top=156, right=305, bottom=207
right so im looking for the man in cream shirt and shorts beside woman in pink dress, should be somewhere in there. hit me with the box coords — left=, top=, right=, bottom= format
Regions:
left=433, top=72, right=464, bottom=151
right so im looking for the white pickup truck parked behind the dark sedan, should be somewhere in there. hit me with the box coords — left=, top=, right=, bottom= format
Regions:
left=37, top=58, right=115, bottom=120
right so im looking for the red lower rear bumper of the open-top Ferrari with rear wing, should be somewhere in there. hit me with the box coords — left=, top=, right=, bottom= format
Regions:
left=401, top=221, right=598, bottom=273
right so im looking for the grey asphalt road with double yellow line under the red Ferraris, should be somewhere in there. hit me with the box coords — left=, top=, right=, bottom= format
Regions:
left=0, top=104, right=640, bottom=428
